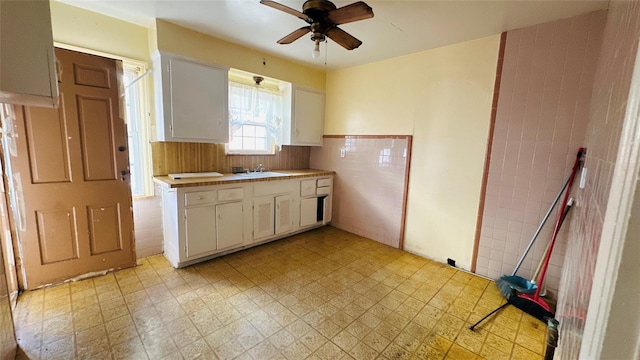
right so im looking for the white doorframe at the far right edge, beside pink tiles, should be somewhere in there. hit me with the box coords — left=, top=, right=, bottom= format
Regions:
left=579, top=40, right=640, bottom=359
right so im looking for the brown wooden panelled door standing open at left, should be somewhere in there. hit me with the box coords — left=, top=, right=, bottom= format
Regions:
left=13, top=49, right=135, bottom=289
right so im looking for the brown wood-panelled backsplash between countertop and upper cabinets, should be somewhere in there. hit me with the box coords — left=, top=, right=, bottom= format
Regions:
left=151, top=142, right=310, bottom=176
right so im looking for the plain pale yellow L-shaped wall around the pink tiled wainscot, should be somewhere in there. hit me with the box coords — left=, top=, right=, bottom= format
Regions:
left=325, top=35, right=500, bottom=269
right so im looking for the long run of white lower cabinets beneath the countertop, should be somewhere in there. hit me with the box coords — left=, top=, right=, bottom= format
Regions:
left=162, top=177, right=332, bottom=267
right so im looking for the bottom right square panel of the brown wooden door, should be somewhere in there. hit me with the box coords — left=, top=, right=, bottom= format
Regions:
left=87, top=204, right=122, bottom=255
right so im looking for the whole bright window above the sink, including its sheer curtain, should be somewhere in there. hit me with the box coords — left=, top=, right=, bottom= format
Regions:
left=227, top=81, right=282, bottom=154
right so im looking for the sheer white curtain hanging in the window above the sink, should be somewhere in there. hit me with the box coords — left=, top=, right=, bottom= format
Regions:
left=229, top=81, right=282, bottom=148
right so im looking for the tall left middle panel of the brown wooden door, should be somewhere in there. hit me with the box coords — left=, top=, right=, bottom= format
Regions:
left=25, top=98, right=71, bottom=184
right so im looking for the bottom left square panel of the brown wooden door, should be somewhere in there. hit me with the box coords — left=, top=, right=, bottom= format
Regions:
left=36, top=209, right=78, bottom=264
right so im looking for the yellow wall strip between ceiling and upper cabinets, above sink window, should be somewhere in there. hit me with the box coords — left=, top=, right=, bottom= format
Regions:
left=151, top=20, right=325, bottom=90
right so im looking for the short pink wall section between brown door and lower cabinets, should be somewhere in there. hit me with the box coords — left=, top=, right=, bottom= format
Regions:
left=133, top=187, right=162, bottom=258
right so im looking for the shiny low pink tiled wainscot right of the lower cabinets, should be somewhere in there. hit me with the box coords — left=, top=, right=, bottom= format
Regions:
left=311, top=136, right=410, bottom=248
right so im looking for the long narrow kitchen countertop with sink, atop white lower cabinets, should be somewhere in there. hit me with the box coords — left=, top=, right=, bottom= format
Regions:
left=153, top=169, right=335, bottom=188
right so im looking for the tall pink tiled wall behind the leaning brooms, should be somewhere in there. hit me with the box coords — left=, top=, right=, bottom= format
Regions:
left=476, top=11, right=606, bottom=293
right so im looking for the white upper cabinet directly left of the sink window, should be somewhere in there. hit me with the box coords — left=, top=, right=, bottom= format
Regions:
left=153, top=53, right=229, bottom=143
